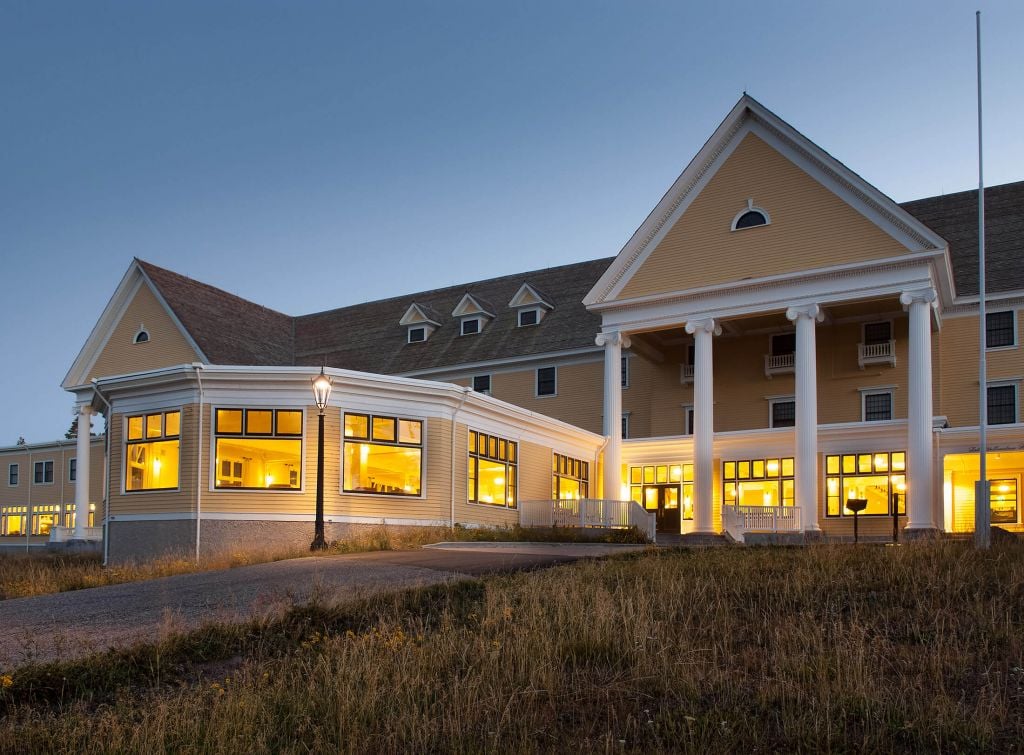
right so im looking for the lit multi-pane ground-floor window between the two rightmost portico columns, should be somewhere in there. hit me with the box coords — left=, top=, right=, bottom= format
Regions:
left=825, top=451, right=906, bottom=516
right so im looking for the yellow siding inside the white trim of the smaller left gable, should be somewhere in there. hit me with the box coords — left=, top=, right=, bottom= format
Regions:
left=89, top=283, right=199, bottom=379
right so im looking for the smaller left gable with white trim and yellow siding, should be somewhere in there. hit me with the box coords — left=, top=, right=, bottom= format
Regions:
left=61, top=260, right=208, bottom=390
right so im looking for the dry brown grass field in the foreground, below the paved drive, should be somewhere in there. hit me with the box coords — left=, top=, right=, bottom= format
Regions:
left=0, top=543, right=1024, bottom=753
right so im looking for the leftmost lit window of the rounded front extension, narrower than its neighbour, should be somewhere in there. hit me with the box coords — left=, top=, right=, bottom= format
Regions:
left=125, top=411, right=181, bottom=492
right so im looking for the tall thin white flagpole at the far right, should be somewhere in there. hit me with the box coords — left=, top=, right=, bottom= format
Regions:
left=974, top=10, right=992, bottom=549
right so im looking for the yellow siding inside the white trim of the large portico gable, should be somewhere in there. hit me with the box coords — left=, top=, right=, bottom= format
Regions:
left=616, top=134, right=906, bottom=299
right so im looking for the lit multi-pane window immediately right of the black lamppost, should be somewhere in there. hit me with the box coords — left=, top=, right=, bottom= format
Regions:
left=342, top=414, right=423, bottom=496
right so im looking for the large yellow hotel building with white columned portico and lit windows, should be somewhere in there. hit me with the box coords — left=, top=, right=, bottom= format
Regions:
left=41, top=95, right=1024, bottom=558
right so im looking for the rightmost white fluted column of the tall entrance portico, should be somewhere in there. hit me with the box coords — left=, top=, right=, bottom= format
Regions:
left=899, top=289, right=937, bottom=530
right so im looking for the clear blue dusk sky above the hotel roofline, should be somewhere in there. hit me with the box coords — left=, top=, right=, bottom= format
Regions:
left=0, top=0, right=1024, bottom=445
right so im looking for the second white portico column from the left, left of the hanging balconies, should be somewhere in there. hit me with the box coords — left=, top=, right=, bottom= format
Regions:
left=686, top=320, right=722, bottom=533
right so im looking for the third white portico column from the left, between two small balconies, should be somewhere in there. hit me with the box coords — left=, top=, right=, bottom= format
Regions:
left=785, top=304, right=824, bottom=532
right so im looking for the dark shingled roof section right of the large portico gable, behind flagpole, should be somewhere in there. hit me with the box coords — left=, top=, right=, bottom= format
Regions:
left=900, top=181, right=1024, bottom=296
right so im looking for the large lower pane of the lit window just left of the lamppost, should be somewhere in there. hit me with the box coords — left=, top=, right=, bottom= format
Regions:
left=216, top=437, right=302, bottom=490
